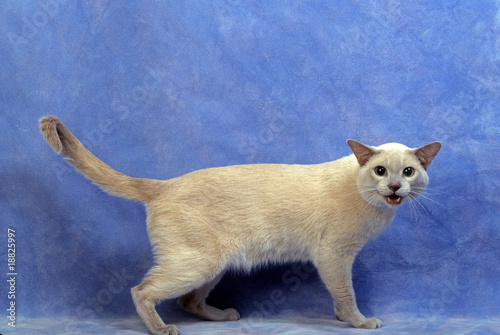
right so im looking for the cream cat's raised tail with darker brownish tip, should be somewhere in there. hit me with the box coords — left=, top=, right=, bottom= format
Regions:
left=39, top=116, right=164, bottom=202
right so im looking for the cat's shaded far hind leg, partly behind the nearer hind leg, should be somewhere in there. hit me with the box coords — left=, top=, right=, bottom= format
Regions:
left=177, top=272, right=240, bottom=321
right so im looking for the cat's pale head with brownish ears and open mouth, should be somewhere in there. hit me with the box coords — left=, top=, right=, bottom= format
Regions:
left=347, top=140, right=441, bottom=209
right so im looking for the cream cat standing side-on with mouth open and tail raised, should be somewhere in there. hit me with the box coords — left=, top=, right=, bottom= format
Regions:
left=39, top=116, right=441, bottom=335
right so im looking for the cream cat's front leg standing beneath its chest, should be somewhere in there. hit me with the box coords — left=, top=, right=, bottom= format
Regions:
left=316, top=248, right=382, bottom=329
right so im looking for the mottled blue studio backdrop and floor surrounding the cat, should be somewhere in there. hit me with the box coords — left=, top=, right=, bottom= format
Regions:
left=0, top=0, right=500, bottom=334
